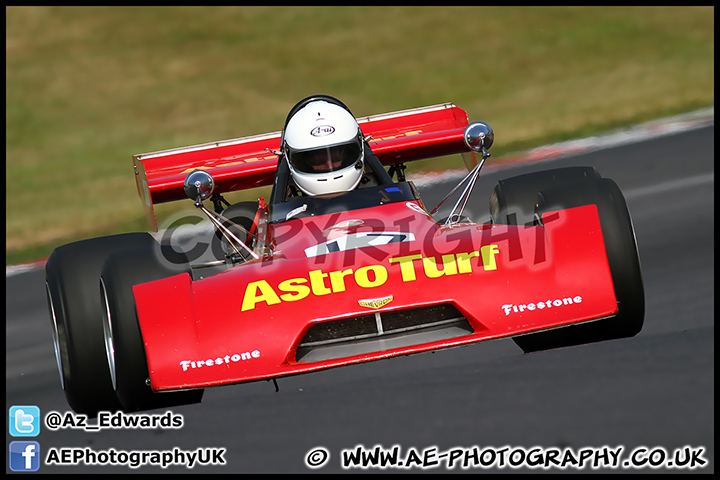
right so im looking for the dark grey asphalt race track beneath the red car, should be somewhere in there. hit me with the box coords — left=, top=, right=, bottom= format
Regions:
left=5, top=126, right=715, bottom=473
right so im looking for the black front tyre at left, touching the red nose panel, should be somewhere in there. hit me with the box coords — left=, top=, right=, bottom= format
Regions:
left=100, top=245, right=203, bottom=411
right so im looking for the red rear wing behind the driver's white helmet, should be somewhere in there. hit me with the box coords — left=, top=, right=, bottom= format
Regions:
left=133, top=103, right=475, bottom=231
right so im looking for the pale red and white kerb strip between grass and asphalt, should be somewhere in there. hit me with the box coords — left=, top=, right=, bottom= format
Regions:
left=5, top=107, right=715, bottom=278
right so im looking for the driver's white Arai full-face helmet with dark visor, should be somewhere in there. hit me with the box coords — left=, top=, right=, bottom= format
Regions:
left=282, top=100, right=364, bottom=196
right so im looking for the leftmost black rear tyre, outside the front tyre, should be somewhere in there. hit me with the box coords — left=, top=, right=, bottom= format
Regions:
left=45, top=233, right=157, bottom=417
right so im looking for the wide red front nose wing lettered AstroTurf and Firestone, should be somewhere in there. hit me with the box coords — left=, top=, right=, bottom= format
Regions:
left=133, top=205, right=618, bottom=391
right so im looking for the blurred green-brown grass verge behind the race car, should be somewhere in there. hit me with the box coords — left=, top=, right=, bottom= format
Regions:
left=6, top=7, right=714, bottom=264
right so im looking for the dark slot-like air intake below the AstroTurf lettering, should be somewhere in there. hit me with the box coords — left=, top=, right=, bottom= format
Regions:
left=295, top=304, right=473, bottom=362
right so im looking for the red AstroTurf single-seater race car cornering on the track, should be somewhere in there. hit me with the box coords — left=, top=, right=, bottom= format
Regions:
left=46, top=95, right=644, bottom=415
